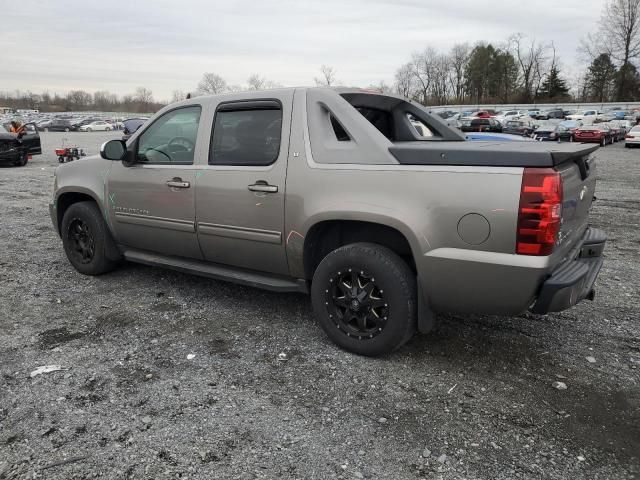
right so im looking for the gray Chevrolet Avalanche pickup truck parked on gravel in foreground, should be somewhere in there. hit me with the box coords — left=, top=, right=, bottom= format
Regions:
left=50, top=88, right=606, bottom=355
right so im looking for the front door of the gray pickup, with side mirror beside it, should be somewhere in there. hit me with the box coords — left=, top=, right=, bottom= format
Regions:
left=107, top=105, right=207, bottom=258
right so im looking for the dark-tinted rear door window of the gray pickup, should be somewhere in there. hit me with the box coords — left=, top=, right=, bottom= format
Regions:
left=209, top=108, right=282, bottom=166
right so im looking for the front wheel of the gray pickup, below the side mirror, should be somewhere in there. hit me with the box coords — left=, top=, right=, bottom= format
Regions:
left=60, top=202, right=118, bottom=275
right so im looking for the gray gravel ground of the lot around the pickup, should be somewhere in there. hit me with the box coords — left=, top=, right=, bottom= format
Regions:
left=0, top=133, right=640, bottom=479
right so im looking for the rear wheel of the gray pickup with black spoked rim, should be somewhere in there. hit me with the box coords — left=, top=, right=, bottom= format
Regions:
left=311, top=243, right=417, bottom=356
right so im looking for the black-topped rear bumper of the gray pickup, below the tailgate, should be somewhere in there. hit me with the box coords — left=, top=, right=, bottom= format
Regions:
left=531, top=228, right=607, bottom=314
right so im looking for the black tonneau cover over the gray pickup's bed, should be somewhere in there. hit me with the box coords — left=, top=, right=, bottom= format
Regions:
left=389, top=141, right=598, bottom=167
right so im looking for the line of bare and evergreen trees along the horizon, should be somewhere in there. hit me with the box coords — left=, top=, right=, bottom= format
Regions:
left=0, top=0, right=640, bottom=113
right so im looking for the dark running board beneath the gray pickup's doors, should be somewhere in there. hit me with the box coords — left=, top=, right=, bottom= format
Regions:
left=123, top=250, right=309, bottom=293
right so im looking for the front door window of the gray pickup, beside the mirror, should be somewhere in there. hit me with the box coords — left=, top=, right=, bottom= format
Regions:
left=136, top=106, right=201, bottom=165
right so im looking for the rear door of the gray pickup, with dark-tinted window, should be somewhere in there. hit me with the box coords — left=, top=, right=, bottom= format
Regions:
left=196, top=92, right=293, bottom=274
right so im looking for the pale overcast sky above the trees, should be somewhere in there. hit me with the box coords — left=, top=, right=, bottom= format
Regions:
left=0, top=0, right=604, bottom=100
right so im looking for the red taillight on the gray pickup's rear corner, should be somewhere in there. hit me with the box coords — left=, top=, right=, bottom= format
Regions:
left=516, top=168, right=562, bottom=255
